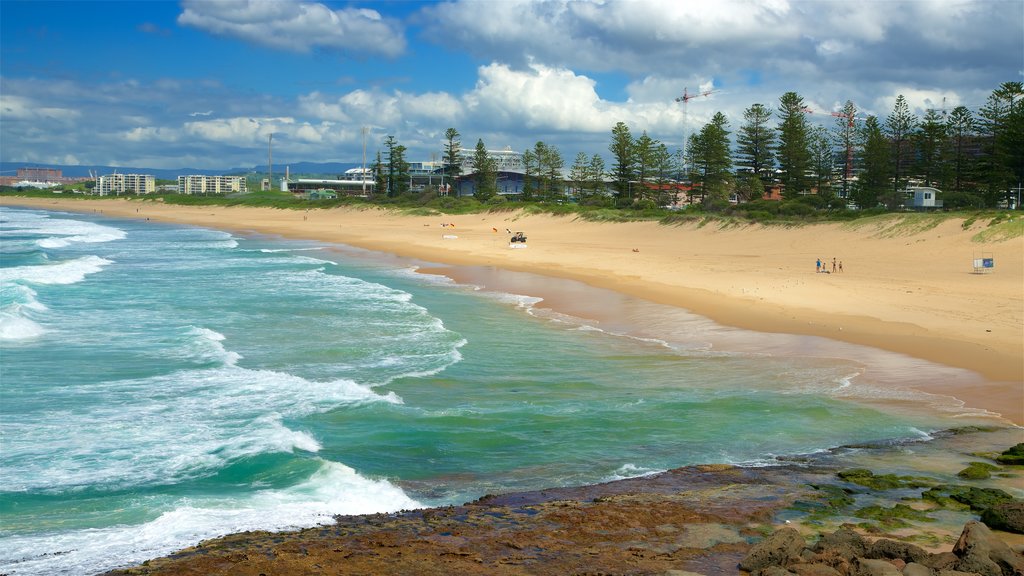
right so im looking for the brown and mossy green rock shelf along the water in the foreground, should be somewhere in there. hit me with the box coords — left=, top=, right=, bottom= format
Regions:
left=101, top=427, right=1024, bottom=576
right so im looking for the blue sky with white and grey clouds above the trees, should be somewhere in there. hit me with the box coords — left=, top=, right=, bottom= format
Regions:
left=0, top=0, right=1024, bottom=171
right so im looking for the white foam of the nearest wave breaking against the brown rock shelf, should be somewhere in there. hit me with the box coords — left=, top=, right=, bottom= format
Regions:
left=0, top=460, right=422, bottom=576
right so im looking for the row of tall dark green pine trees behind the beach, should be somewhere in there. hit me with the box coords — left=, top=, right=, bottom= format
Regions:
left=373, top=82, right=1024, bottom=210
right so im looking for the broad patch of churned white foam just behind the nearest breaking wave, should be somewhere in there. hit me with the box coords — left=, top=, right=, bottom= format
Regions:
left=0, top=366, right=402, bottom=492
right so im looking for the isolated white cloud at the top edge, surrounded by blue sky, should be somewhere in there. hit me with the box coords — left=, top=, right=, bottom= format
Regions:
left=178, top=0, right=406, bottom=56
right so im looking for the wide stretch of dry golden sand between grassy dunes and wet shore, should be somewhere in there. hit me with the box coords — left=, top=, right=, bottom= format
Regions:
left=0, top=196, right=1024, bottom=424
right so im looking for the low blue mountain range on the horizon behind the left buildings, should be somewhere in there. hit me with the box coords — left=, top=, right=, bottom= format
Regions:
left=0, top=162, right=359, bottom=180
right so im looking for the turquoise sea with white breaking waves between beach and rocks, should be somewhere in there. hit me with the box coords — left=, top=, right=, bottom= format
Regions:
left=0, top=204, right=991, bottom=575
